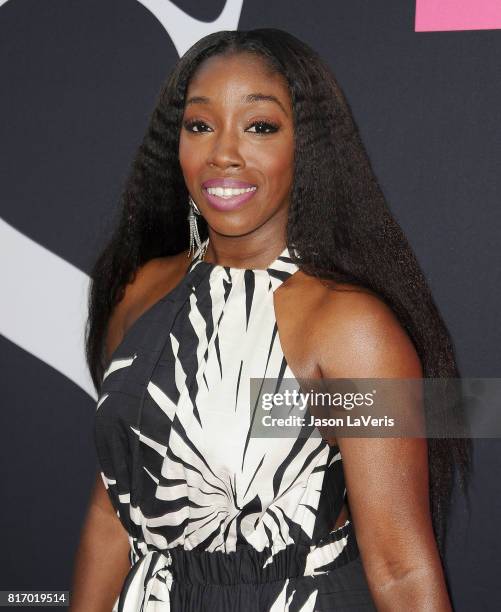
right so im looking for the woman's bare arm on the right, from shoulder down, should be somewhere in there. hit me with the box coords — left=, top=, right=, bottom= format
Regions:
left=317, top=291, right=452, bottom=612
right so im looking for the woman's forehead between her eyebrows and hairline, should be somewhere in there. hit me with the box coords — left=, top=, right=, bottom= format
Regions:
left=187, top=53, right=289, bottom=104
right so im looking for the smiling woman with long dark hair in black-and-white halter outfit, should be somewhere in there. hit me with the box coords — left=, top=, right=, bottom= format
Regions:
left=71, top=29, right=470, bottom=612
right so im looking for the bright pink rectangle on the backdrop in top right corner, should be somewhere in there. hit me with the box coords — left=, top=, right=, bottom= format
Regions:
left=415, top=0, right=501, bottom=32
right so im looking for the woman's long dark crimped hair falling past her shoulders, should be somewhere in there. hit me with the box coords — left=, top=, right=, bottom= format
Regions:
left=85, top=28, right=472, bottom=560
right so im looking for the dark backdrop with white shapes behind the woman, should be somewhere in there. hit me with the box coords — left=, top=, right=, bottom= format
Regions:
left=0, top=0, right=501, bottom=611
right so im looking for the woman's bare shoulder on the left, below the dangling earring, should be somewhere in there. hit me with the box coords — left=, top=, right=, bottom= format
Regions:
left=106, top=251, right=190, bottom=359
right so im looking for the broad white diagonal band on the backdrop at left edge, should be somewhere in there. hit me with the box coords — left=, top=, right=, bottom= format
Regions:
left=0, top=219, right=96, bottom=398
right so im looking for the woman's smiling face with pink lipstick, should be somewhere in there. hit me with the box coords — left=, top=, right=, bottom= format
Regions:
left=179, top=53, right=294, bottom=241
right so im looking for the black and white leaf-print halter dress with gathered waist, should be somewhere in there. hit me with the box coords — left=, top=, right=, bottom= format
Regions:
left=94, top=240, right=375, bottom=612
